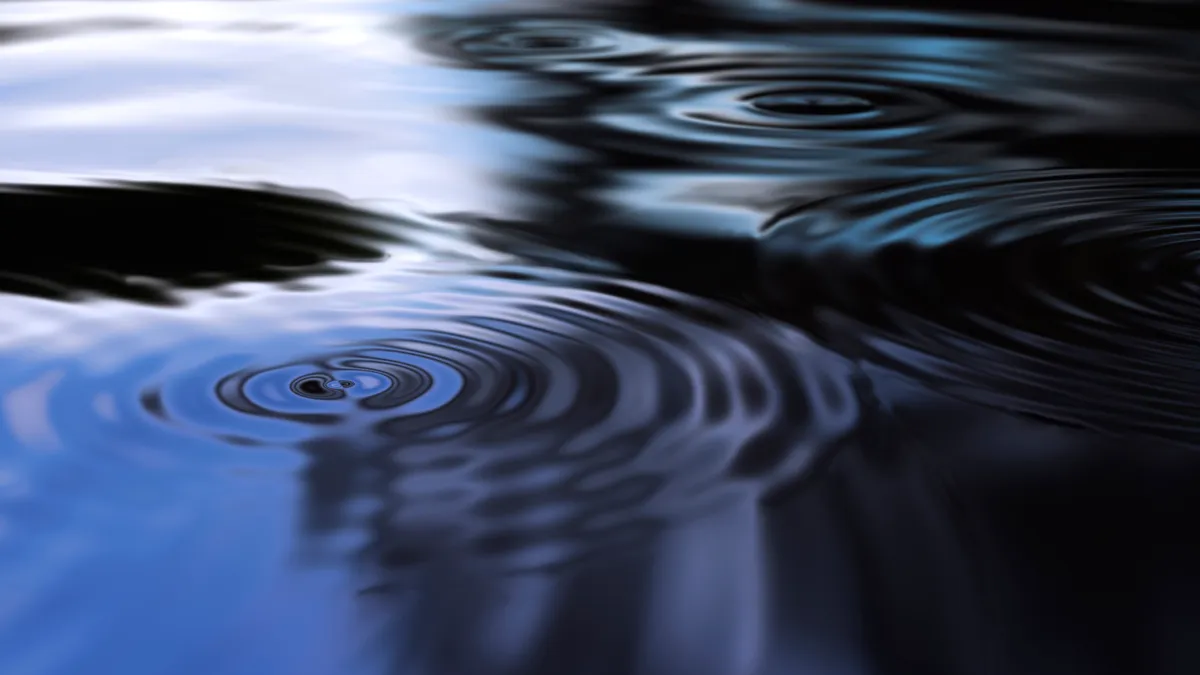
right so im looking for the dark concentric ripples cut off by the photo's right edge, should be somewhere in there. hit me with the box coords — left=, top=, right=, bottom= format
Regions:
left=763, top=171, right=1200, bottom=440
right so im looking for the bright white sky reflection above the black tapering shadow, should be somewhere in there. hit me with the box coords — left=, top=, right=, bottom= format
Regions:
left=0, top=2, right=571, bottom=213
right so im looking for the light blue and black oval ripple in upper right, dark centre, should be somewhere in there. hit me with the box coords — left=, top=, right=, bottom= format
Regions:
left=583, top=44, right=1040, bottom=172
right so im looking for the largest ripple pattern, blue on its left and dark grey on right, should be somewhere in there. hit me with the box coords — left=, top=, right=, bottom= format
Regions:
left=0, top=268, right=858, bottom=634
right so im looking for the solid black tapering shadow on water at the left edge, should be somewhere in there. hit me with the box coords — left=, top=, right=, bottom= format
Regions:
left=0, top=183, right=403, bottom=304
